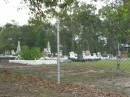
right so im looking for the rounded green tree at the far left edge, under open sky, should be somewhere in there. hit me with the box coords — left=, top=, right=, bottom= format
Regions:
left=0, top=23, right=21, bottom=50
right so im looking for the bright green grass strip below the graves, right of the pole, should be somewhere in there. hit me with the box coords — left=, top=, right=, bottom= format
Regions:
left=62, top=60, right=130, bottom=72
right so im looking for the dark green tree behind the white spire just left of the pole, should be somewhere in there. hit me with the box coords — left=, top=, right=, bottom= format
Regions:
left=35, top=23, right=56, bottom=53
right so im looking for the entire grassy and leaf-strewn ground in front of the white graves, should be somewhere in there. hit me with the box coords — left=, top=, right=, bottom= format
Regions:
left=0, top=60, right=130, bottom=97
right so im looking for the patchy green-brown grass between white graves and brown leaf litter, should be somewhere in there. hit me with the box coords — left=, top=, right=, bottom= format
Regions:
left=0, top=59, right=130, bottom=97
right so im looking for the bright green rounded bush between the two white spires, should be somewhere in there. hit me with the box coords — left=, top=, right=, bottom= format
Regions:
left=20, top=46, right=42, bottom=60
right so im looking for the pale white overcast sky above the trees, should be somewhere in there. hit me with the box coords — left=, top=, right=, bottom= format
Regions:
left=0, top=0, right=104, bottom=26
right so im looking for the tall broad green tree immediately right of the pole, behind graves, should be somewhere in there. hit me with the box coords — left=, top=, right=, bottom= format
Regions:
left=53, top=2, right=101, bottom=54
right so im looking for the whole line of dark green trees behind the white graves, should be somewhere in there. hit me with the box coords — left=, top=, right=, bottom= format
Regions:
left=0, top=0, right=130, bottom=55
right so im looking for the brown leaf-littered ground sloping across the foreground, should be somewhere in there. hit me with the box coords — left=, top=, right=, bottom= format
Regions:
left=0, top=70, right=128, bottom=97
